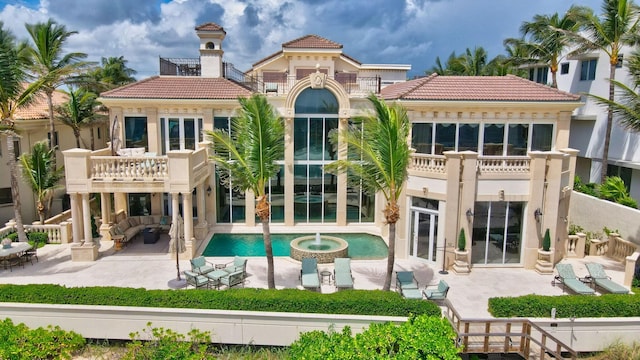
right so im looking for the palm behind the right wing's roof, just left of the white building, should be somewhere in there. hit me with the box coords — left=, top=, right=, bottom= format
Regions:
left=508, top=9, right=580, bottom=88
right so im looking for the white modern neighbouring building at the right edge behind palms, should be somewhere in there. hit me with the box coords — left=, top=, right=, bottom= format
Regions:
left=529, top=47, right=640, bottom=200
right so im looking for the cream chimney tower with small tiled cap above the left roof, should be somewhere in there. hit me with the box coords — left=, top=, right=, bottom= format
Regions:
left=196, top=23, right=227, bottom=78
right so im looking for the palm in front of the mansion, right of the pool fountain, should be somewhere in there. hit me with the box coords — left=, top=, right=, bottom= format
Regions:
left=326, top=94, right=411, bottom=290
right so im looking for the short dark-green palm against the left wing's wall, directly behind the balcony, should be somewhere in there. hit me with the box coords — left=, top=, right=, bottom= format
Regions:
left=54, top=88, right=104, bottom=150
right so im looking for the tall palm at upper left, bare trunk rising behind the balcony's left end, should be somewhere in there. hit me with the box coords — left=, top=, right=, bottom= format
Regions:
left=25, top=19, right=89, bottom=155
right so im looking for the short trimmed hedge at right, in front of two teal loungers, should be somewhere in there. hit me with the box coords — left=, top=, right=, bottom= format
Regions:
left=489, top=294, right=640, bottom=318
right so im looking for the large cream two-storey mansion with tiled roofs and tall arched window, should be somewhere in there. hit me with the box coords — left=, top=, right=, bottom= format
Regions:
left=64, top=23, right=581, bottom=271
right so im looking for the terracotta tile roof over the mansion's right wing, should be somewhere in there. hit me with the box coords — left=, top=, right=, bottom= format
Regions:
left=380, top=74, right=580, bottom=101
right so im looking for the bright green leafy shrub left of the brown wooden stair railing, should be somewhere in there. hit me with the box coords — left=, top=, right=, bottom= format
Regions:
left=289, top=316, right=459, bottom=360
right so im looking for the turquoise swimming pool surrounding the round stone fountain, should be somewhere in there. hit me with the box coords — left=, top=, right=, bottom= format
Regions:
left=202, top=233, right=389, bottom=260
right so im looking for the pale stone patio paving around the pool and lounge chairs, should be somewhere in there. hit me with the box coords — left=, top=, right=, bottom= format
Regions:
left=0, top=235, right=624, bottom=318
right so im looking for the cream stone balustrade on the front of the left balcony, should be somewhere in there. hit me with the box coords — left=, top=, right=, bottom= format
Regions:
left=91, top=156, right=169, bottom=180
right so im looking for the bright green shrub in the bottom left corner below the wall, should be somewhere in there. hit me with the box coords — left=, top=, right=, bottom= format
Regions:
left=0, top=319, right=85, bottom=360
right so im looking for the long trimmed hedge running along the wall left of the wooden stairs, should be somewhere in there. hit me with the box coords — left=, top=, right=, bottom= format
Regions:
left=0, top=284, right=441, bottom=316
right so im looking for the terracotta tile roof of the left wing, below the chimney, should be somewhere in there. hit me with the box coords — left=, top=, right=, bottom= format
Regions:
left=100, top=76, right=252, bottom=100
